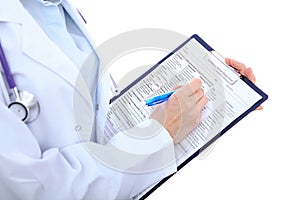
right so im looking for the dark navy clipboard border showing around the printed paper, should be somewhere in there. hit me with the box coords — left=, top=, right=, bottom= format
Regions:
left=110, top=34, right=268, bottom=199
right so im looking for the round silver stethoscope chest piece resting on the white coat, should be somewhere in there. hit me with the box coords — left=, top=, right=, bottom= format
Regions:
left=8, top=91, right=40, bottom=123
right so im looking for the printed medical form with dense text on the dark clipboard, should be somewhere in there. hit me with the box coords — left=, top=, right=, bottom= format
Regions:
left=104, top=35, right=267, bottom=198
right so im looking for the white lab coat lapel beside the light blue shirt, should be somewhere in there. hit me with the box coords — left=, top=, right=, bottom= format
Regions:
left=0, top=0, right=90, bottom=104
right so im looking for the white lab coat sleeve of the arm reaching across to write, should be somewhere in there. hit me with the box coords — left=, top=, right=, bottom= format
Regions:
left=0, top=102, right=176, bottom=200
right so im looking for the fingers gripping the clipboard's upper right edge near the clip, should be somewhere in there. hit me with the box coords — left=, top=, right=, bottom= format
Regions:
left=225, top=58, right=263, bottom=110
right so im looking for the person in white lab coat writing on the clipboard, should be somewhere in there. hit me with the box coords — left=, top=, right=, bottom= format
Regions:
left=0, top=0, right=255, bottom=199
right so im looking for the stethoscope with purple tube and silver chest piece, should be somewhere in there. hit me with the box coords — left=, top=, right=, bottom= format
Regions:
left=0, top=42, right=40, bottom=123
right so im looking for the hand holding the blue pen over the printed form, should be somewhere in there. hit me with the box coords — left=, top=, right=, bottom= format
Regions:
left=150, top=79, right=208, bottom=144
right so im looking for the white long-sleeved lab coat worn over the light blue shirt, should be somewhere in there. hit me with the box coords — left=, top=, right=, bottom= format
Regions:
left=0, top=0, right=176, bottom=200
